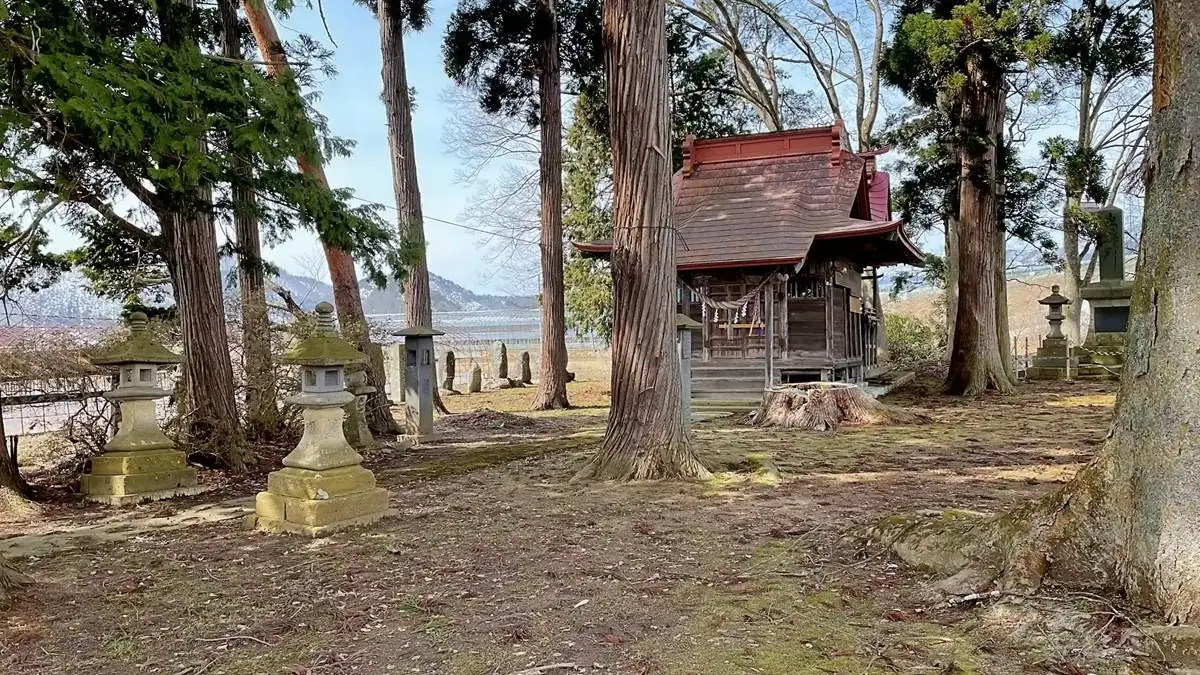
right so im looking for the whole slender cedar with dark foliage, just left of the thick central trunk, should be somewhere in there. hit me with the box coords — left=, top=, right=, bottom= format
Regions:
left=443, top=0, right=570, bottom=410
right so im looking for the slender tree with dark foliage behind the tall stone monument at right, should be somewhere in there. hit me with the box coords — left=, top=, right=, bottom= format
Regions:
left=1045, top=0, right=1151, bottom=342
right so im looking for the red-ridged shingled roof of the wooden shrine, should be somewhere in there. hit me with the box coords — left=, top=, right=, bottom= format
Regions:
left=576, top=121, right=920, bottom=269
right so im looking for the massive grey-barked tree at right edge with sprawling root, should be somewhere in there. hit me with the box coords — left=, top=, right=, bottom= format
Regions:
left=880, top=0, right=1200, bottom=626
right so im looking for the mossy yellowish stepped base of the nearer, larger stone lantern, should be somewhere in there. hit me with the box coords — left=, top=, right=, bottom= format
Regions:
left=245, top=465, right=389, bottom=537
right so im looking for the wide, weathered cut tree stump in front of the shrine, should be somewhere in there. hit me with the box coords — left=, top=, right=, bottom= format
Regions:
left=750, top=382, right=931, bottom=431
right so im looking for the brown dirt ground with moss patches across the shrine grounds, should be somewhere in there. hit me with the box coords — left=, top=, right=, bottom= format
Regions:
left=0, top=365, right=1164, bottom=675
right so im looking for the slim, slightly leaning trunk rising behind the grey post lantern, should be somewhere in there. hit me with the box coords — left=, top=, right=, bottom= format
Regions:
left=377, top=0, right=450, bottom=414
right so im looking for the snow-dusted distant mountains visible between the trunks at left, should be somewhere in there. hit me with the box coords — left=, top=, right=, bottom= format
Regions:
left=9, top=261, right=538, bottom=325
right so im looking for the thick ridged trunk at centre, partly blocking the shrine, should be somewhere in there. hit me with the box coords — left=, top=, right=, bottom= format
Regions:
left=578, top=0, right=709, bottom=479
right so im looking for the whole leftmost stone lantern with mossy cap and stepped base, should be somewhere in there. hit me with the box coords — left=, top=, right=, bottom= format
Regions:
left=79, top=312, right=202, bottom=506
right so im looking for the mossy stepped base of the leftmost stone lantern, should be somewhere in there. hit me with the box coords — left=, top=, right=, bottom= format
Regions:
left=79, top=450, right=204, bottom=506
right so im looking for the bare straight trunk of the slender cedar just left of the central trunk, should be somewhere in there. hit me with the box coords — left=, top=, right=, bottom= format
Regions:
left=533, top=0, right=571, bottom=410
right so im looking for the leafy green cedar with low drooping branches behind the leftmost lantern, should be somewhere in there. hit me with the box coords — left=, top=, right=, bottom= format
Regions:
left=0, top=0, right=403, bottom=461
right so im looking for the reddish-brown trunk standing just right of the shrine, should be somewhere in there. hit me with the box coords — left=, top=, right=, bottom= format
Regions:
left=946, top=58, right=1013, bottom=395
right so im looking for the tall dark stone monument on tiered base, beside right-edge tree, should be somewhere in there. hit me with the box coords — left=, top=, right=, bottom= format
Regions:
left=1076, top=207, right=1133, bottom=380
